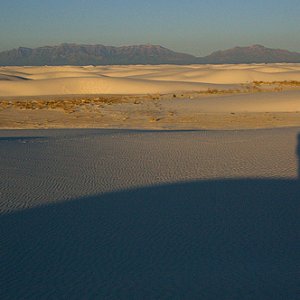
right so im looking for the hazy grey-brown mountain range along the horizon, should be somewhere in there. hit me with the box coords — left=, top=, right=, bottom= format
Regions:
left=0, top=44, right=300, bottom=66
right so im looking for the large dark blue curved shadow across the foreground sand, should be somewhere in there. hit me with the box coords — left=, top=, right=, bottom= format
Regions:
left=0, top=179, right=300, bottom=300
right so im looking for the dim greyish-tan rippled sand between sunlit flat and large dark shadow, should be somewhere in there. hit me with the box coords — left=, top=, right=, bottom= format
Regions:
left=0, top=128, right=300, bottom=210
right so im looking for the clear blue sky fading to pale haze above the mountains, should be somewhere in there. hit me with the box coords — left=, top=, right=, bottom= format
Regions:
left=0, top=0, right=300, bottom=56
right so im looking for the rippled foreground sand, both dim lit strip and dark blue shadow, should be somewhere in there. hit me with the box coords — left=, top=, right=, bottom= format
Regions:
left=0, top=128, right=300, bottom=299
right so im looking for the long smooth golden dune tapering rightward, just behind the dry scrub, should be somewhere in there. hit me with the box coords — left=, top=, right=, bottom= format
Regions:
left=0, top=76, right=234, bottom=96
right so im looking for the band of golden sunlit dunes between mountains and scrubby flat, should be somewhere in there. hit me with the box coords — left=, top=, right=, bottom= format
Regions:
left=0, top=64, right=300, bottom=96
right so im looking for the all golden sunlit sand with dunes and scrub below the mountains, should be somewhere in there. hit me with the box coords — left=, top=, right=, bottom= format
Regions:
left=0, top=64, right=300, bottom=129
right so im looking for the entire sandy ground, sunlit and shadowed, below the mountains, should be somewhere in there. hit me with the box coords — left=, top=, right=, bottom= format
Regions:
left=0, top=64, right=300, bottom=299
